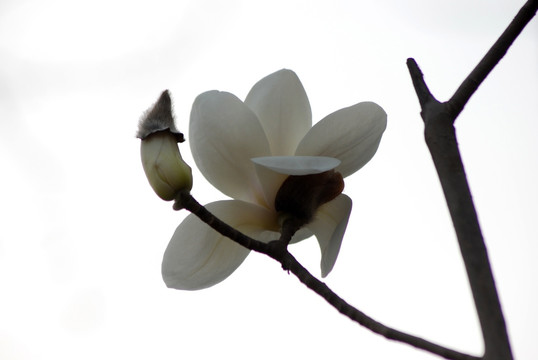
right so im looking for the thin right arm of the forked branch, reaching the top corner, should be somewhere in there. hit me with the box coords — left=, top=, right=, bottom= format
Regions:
left=444, top=0, right=538, bottom=120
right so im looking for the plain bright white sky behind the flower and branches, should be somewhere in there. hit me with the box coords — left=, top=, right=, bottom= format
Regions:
left=0, top=0, right=538, bottom=360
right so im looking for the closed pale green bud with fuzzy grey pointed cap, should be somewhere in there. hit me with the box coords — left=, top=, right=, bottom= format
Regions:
left=137, top=91, right=192, bottom=200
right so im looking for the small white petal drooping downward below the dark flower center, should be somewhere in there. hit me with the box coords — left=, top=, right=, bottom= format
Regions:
left=307, top=194, right=352, bottom=277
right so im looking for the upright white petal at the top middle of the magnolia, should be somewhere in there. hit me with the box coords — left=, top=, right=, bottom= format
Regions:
left=245, top=69, right=312, bottom=155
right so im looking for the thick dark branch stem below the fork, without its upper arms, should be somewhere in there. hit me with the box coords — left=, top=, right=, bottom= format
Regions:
left=406, top=56, right=512, bottom=360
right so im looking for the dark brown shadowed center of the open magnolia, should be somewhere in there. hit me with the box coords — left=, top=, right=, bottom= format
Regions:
left=275, top=170, right=344, bottom=224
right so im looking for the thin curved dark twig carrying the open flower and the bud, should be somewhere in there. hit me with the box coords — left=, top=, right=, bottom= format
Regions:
left=174, top=193, right=480, bottom=360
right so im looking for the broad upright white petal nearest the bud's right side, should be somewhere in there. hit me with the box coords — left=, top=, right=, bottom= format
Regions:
left=189, top=91, right=270, bottom=202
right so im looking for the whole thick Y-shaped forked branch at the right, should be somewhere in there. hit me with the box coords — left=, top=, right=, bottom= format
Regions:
left=407, top=0, right=538, bottom=360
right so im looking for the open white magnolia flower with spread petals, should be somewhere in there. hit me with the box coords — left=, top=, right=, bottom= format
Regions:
left=162, top=70, right=387, bottom=290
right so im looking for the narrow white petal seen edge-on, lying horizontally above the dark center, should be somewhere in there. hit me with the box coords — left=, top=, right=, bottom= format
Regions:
left=252, top=156, right=340, bottom=175
